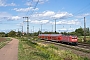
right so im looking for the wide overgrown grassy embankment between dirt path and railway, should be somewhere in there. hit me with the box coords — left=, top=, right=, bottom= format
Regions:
left=18, top=38, right=88, bottom=60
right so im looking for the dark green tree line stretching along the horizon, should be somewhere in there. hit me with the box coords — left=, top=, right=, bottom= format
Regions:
left=0, top=27, right=90, bottom=37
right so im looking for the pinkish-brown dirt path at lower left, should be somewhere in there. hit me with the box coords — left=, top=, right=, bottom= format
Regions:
left=0, top=38, right=19, bottom=60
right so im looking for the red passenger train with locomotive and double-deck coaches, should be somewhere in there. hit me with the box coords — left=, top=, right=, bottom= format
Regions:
left=38, top=34, right=78, bottom=45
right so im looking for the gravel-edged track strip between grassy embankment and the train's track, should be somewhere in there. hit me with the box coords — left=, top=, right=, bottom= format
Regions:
left=29, top=39, right=90, bottom=59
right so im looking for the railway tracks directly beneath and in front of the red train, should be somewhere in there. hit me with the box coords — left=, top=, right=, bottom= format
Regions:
left=35, top=40, right=90, bottom=53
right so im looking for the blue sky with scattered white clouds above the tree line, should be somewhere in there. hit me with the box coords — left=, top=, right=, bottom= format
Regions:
left=0, top=0, right=90, bottom=32
